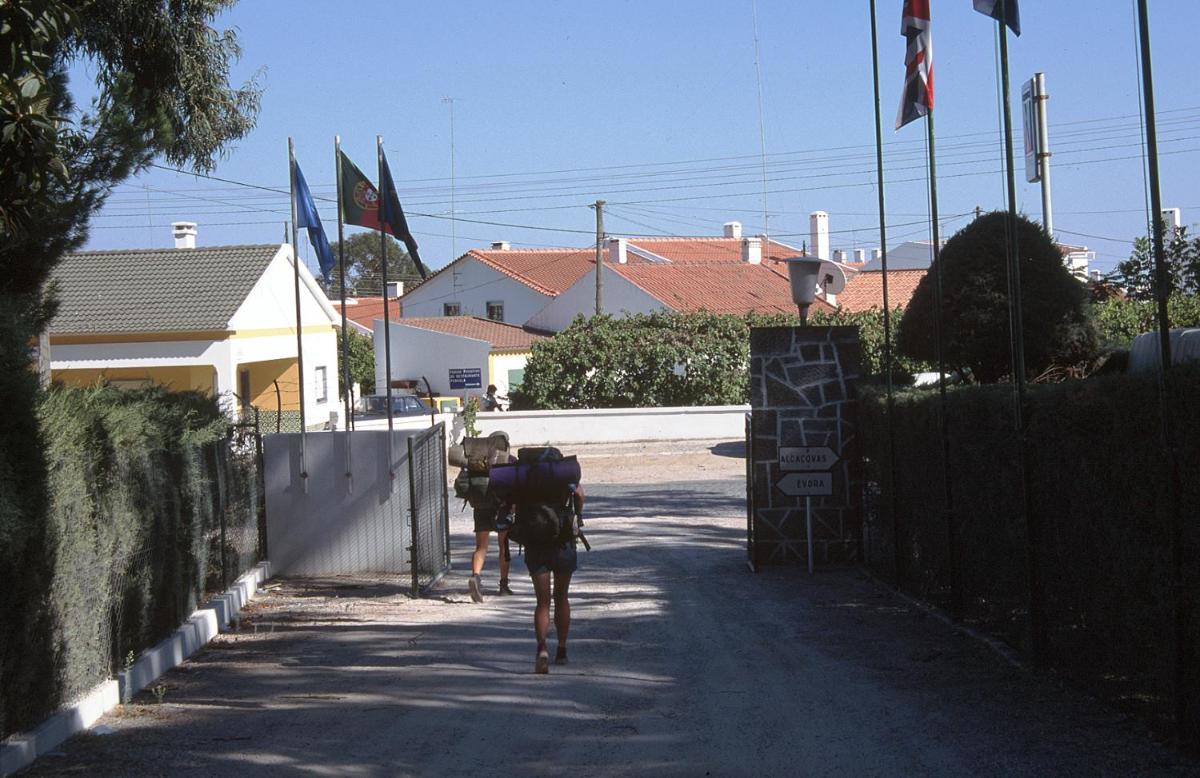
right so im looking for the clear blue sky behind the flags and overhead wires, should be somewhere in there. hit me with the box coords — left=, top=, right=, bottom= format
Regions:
left=73, top=0, right=1200, bottom=280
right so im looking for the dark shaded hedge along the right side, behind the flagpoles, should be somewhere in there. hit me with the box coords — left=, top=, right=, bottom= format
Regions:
left=860, top=367, right=1200, bottom=744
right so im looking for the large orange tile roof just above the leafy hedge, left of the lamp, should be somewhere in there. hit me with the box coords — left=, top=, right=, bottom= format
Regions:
left=610, top=259, right=833, bottom=313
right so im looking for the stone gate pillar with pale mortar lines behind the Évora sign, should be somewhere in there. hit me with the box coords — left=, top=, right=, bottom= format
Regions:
left=748, top=327, right=862, bottom=567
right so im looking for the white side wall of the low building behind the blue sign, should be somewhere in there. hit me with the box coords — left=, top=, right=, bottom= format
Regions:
left=374, top=319, right=491, bottom=395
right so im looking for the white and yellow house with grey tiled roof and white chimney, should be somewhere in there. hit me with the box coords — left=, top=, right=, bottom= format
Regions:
left=49, top=222, right=342, bottom=426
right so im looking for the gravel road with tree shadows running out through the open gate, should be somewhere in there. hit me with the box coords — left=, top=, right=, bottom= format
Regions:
left=21, top=442, right=1200, bottom=776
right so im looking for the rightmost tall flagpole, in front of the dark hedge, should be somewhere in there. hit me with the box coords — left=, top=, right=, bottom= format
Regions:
left=1138, top=0, right=1200, bottom=748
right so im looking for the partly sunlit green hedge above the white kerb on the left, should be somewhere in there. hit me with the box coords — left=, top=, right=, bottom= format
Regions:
left=0, top=387, right=260, bottom=736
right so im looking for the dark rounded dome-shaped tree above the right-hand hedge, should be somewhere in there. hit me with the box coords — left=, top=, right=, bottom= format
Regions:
left=896, top=211, right=1096, bottom=383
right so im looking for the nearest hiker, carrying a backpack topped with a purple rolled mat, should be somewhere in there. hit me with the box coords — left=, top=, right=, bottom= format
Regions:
left=490, top=447, right=588, bottom=674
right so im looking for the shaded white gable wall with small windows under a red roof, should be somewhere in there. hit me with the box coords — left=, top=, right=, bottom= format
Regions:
left=401, top=255, right=552, bottom=324
